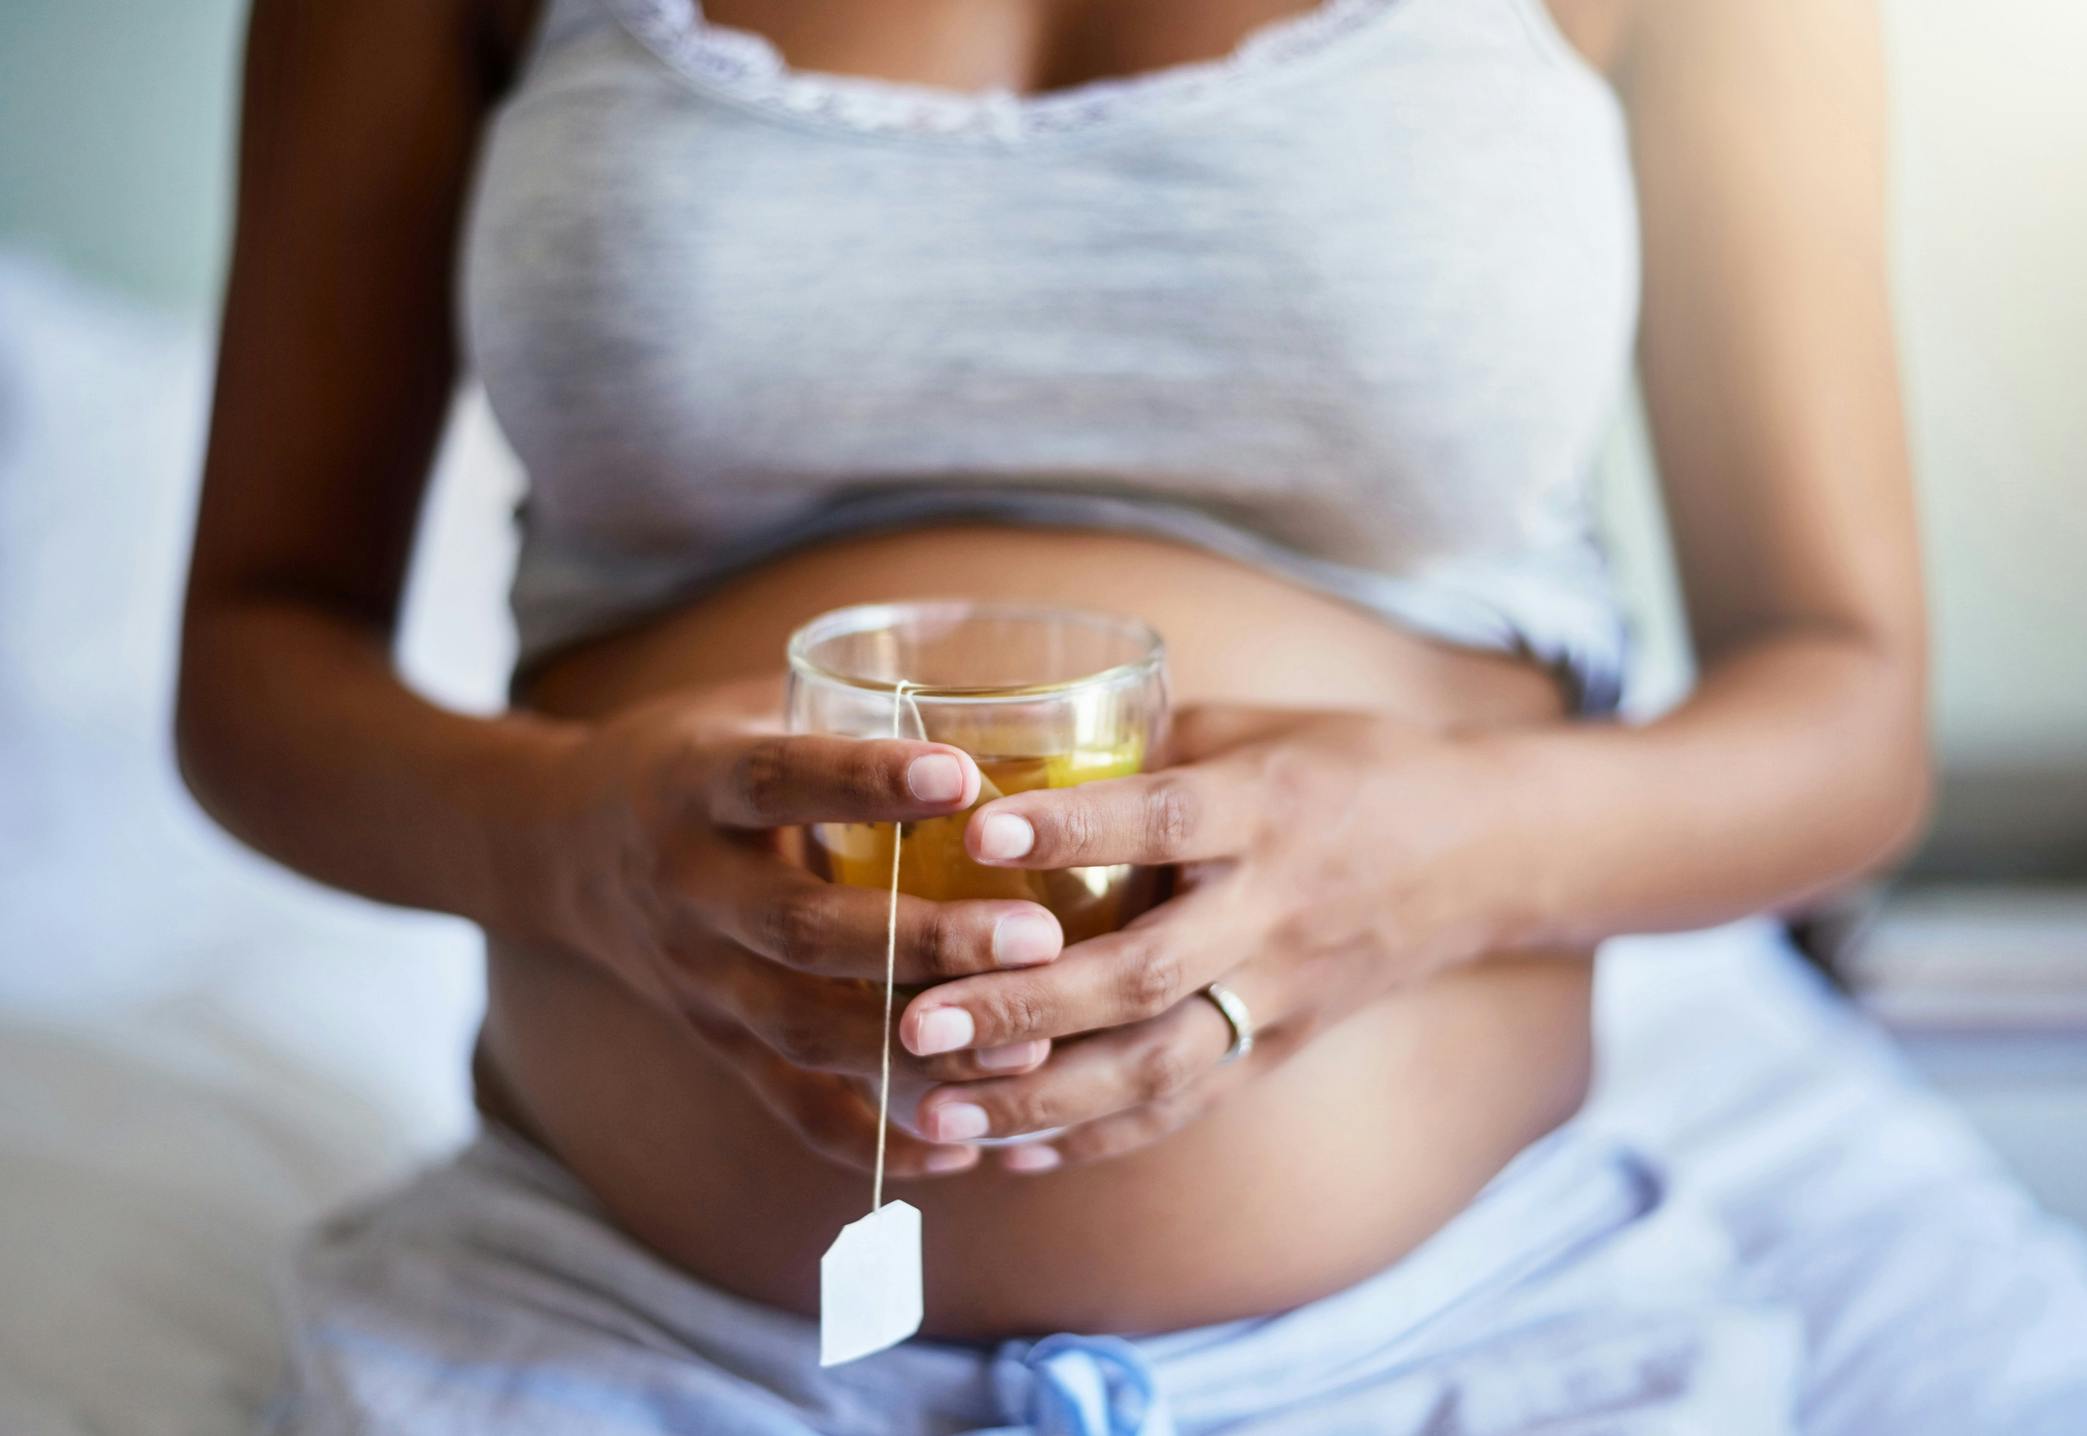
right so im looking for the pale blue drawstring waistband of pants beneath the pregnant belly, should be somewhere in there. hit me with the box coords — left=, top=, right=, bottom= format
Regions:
left=455, top=1123, right=1661, bottom=1436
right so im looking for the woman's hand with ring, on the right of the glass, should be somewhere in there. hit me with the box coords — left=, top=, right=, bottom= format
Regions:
left=899, top=708, right=1511, bottom=1171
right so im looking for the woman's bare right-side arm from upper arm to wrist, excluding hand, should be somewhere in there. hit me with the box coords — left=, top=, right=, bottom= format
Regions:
left=1494, top=0, right=1928, bottom=941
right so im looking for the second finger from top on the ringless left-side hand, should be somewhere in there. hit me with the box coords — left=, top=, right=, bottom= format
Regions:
left=674, top=841, right=1064, bottom=983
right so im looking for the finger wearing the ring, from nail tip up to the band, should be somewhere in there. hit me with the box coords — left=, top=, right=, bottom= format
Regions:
left=916, top=1002, right=1231, bottom=1142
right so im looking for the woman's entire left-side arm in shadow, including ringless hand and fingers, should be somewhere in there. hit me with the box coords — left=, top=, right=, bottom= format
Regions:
left=177, top=0, right=1043, bottom=1177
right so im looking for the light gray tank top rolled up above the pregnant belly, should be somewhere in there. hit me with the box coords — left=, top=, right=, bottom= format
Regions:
left=463, top=0, right=1638, bottom=710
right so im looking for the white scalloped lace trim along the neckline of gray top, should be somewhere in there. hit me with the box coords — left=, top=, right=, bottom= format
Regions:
left=607, top=0, right=1400, bottom=142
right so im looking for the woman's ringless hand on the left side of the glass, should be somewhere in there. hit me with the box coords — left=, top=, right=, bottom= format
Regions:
left=515, top=683, right=1064, bottom=1177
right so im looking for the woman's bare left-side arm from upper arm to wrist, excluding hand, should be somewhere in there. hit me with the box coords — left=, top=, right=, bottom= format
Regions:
left=175, top=0, right=572, bottom=931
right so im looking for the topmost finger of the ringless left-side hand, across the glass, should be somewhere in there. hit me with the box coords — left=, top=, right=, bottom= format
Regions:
left=703, top=735, right=979, bottom=829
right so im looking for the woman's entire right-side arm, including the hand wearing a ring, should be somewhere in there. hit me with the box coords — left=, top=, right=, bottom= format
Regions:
left=899, top=0, right=1928, bottom=1169
